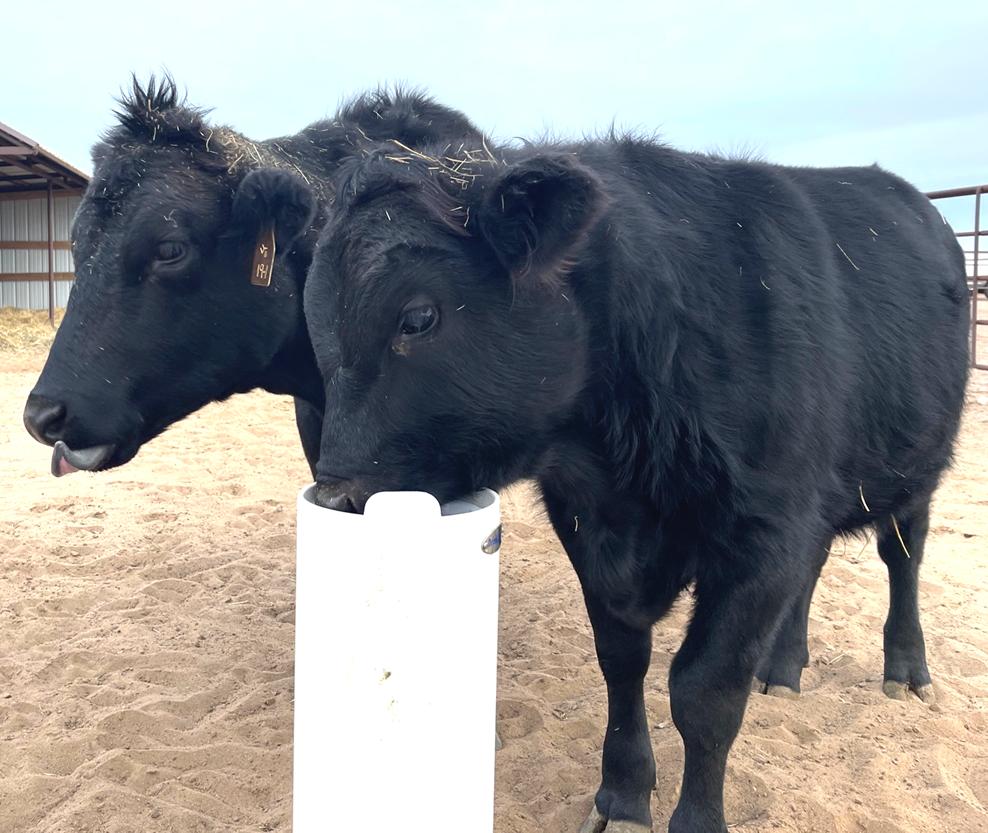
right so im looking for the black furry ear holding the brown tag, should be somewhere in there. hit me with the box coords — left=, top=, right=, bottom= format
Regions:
left=233, top=168, right=316, bottom=250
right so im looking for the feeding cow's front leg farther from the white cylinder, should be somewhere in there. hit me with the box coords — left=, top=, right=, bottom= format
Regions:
left=669, top=544, right=811, bottom=833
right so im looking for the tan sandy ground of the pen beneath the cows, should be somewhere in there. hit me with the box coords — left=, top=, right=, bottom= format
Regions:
left=0, top=316, right=988, bottom=833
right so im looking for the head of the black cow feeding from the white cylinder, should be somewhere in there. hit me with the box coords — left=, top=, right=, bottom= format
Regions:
left=305, top=145, right=603, bottom=511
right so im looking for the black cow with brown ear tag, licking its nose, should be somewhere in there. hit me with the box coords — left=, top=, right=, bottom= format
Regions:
left=24, top=78, right=477, bottom=475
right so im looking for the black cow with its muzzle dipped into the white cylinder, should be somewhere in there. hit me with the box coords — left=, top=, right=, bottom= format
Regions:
left=305, top=133, right=968, bottom=833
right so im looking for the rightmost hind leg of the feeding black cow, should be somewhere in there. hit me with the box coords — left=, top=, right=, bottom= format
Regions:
left=876, top=500, right=936, bottom=703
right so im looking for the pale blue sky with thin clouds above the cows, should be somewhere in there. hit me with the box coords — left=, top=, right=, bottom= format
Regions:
left=0, top=0, right=988, bottom=234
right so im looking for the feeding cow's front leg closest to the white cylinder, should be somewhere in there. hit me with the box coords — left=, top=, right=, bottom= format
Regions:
left=580, top=596, right=655, bottom=833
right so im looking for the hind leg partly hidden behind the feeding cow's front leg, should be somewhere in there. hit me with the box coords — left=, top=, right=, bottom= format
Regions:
left=751, top=542, right=830, bottom=698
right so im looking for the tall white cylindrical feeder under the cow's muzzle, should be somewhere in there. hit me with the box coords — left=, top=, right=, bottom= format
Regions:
left=293, top=486, right=500, bottom=833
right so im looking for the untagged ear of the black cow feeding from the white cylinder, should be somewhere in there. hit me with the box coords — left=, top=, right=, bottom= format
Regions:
left=478, top=154, right=606, bottom=283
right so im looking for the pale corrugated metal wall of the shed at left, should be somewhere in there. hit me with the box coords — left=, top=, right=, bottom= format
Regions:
left=0, top=191, right=81, bottom=309
